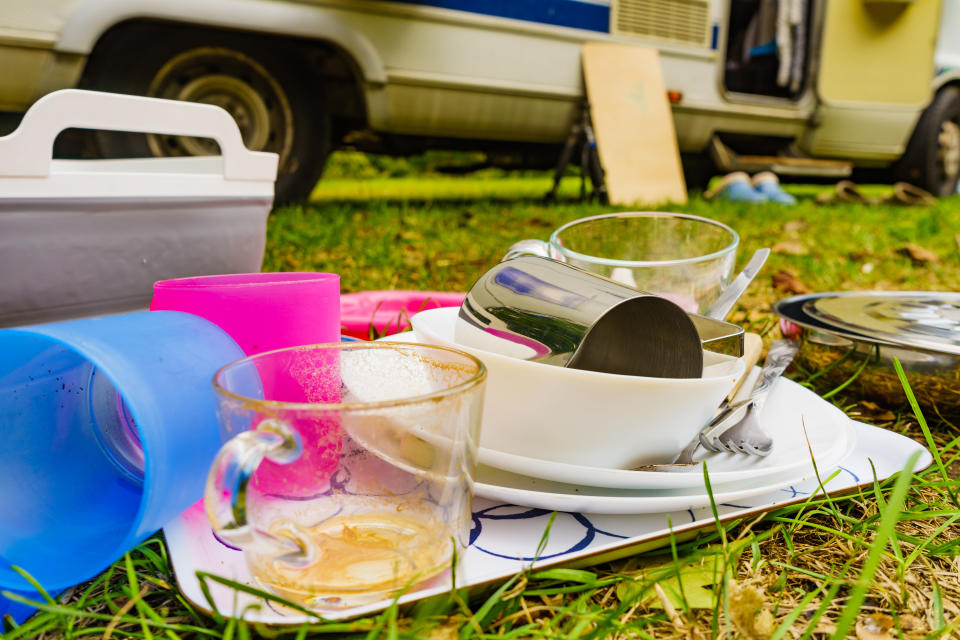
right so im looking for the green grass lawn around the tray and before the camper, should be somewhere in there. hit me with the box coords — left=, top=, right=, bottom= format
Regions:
left=5, top=172, right=960, bottom=639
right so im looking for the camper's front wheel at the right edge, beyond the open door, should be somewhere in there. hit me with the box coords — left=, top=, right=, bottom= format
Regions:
left=894, top=86, right=960, bottom=197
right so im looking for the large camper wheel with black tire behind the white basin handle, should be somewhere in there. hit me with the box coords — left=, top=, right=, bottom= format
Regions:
left=82, top=24, right=330, bottom=204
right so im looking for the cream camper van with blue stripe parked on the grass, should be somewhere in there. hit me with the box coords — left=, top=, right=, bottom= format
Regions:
left=0, top=0, right=960, bottom=200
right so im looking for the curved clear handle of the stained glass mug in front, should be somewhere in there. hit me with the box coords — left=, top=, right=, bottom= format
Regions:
left=203, top=420, right=312, bottom=565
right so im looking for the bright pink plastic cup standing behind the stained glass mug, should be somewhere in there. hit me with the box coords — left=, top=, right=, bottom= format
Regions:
left=150, top=272, right=340, bottom=498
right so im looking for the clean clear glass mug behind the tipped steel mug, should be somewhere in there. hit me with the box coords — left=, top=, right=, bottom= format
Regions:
left=504, top=212, right=740, bottom=313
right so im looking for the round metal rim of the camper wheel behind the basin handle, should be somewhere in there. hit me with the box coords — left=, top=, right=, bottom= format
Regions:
left=147, top=47, right=293, bottom=166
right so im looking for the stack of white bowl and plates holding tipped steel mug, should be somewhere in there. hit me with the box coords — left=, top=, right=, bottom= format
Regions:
left=399, top=244, right=849, bottom=504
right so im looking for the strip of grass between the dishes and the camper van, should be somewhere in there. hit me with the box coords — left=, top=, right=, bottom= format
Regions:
left=282, top=176, right=960, bottom=298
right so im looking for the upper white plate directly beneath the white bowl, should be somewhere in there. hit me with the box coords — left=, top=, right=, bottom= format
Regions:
left=479, top=378, right=849, bottom=489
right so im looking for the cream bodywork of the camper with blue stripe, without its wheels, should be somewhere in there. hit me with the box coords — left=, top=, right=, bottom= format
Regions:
left=0, top=0, right=944, bottom=169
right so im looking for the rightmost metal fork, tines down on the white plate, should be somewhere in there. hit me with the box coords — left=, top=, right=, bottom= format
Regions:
left=700, top=340, right=800, bottom=456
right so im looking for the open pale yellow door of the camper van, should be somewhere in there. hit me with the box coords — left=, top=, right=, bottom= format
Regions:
left=801, top=0, right=940, bottom=166
